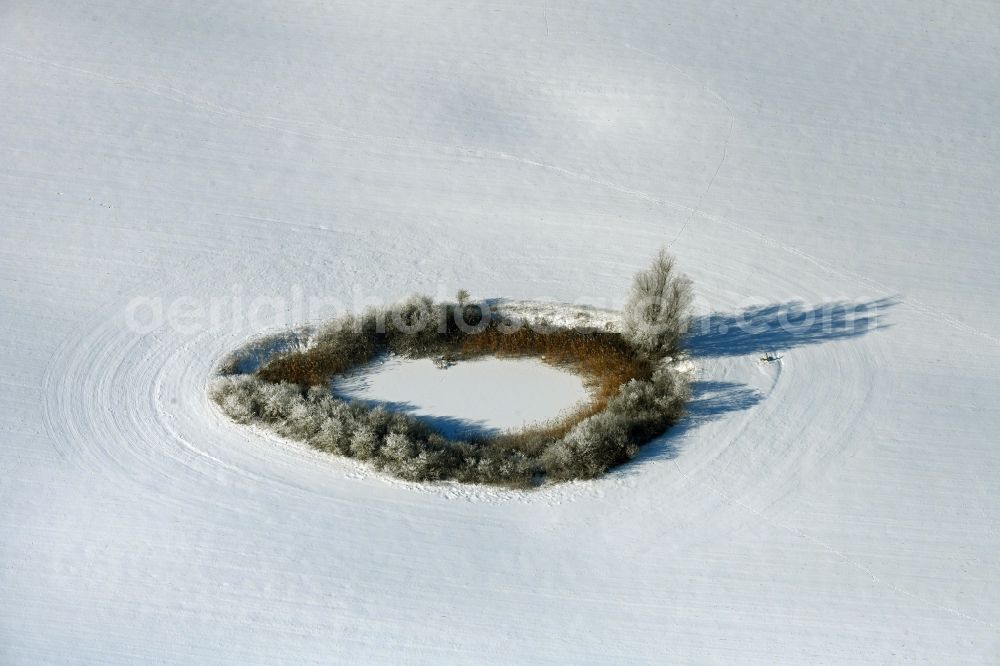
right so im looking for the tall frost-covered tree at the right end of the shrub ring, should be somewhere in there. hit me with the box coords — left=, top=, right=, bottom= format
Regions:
left=624, top=249, right=694, bottom=358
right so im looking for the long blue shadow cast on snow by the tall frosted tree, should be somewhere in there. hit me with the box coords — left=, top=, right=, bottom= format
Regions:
left=687, top=298, right=899, bottom=357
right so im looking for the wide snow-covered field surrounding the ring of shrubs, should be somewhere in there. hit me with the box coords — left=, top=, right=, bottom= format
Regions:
left=0, top=0, right=1000, bottom=664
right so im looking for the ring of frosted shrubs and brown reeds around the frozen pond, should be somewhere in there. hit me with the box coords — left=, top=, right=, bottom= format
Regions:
left=210, top=246, right=690, bottom=487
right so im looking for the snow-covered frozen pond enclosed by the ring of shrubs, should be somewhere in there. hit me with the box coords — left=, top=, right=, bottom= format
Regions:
left=332, top=357, right=590, bottom=437
